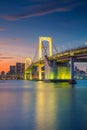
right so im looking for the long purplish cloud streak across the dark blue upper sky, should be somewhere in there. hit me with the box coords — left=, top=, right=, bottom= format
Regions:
left=2, top=0, right=85, bottom=20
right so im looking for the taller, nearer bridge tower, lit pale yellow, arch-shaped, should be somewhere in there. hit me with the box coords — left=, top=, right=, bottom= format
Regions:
left=38, top=37, right=52, bottom=80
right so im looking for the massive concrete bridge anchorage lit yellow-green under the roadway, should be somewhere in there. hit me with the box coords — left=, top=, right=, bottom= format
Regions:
left=44, top=57, right=71, bottom=81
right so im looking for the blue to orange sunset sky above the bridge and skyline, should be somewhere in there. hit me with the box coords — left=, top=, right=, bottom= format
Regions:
left=0, top=0, right=87, bottom=72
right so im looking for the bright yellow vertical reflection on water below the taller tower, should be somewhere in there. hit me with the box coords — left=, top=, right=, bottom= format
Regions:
left=36, top=84, right=57, bottom=130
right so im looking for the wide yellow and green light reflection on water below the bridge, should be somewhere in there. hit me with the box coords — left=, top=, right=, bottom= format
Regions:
left=36, top=83, right=71, bottom=130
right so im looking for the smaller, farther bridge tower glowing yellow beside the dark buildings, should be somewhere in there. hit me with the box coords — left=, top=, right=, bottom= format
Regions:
left=24, top=58, right=32, bottom=80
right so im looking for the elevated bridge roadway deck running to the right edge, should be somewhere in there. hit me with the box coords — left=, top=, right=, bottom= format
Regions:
left=33, top=46, right=87, bottom=65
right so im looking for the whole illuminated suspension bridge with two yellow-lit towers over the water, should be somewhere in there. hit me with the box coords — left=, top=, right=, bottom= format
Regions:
left=25, top=37, right=87, bottom=83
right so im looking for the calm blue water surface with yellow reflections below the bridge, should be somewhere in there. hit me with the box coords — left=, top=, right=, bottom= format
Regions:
left=0, top=80, right=87, bottom=130
